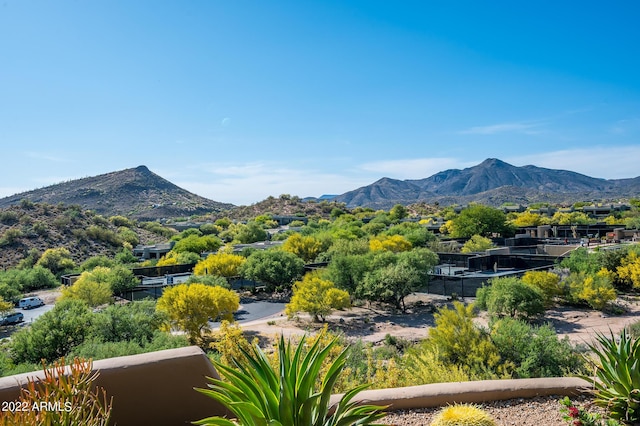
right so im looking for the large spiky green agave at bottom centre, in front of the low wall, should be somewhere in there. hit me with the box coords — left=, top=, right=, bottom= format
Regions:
left=194, top=335, right=386, bottom=426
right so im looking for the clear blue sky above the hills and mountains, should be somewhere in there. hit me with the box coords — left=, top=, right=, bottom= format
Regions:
left=0, top=0, right=640, bottom=204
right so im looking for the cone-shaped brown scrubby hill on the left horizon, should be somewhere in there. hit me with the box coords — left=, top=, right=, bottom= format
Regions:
left=0, top=166, right=234, bottom=220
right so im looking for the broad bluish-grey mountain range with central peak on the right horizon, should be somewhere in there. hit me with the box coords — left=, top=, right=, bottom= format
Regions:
left=333, top=158, right=640, bottom=209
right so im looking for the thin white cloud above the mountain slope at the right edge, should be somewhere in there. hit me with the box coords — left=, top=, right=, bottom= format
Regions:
left=502, top=145, right=640, bottom=179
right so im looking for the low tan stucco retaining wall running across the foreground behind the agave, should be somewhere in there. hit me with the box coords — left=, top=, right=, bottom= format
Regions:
left=0, top=346, right=592, bottom=426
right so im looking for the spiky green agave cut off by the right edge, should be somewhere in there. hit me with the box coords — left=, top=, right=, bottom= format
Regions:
left=583, top=329, right=640, bottom=424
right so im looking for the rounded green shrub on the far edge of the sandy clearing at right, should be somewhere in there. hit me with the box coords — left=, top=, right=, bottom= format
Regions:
left=476, top=277, right=544, bottom=319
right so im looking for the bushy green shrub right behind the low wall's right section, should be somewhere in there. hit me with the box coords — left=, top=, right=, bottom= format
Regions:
left=491, top=318, right=583, bottom=378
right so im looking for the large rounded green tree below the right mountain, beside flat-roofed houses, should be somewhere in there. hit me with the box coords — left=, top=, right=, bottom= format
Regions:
left=450, top=204, right=513, bottom=238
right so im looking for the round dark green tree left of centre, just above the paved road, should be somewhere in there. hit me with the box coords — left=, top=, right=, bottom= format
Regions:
left=241, top=250, right=304, bottom=291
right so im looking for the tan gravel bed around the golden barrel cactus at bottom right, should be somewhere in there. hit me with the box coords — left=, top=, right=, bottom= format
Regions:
left=381, top=396, right=598, bottom=426
